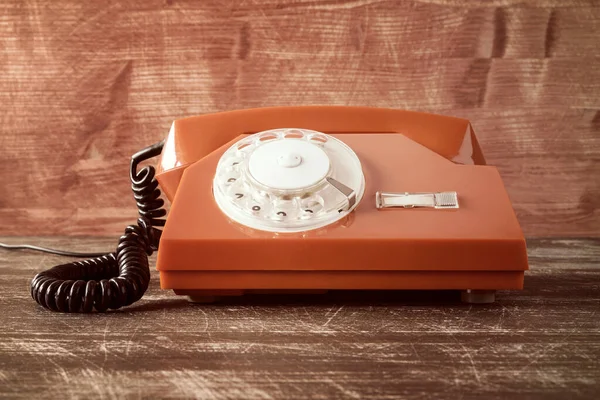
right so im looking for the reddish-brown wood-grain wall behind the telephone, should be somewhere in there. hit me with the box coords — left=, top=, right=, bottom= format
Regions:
left=0, top=0, right=600, bottom=236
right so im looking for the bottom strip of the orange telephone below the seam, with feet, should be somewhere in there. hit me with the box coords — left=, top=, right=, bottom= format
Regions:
left=166, top=270, right=524, bottom=304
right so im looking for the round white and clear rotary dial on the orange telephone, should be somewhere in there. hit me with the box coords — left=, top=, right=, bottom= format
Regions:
left=213, top=128, right=365, bottom=232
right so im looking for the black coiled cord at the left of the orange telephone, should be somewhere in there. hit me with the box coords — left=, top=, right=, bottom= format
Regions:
left=31, top=142, right=167, bottom=313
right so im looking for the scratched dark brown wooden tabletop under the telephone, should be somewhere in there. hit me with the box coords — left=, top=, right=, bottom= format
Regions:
left=0, top=237, right=600, bottom=399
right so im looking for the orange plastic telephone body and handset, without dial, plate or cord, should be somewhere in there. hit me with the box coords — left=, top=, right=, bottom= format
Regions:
left=157, top=107, right=528, bottom=294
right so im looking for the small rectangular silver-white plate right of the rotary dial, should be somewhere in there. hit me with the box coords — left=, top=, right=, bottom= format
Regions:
left=375, top=192, right=458, bottom=209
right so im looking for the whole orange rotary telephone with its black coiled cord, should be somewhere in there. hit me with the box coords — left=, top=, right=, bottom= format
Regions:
left=18, top=106, right=528, bottom=312
